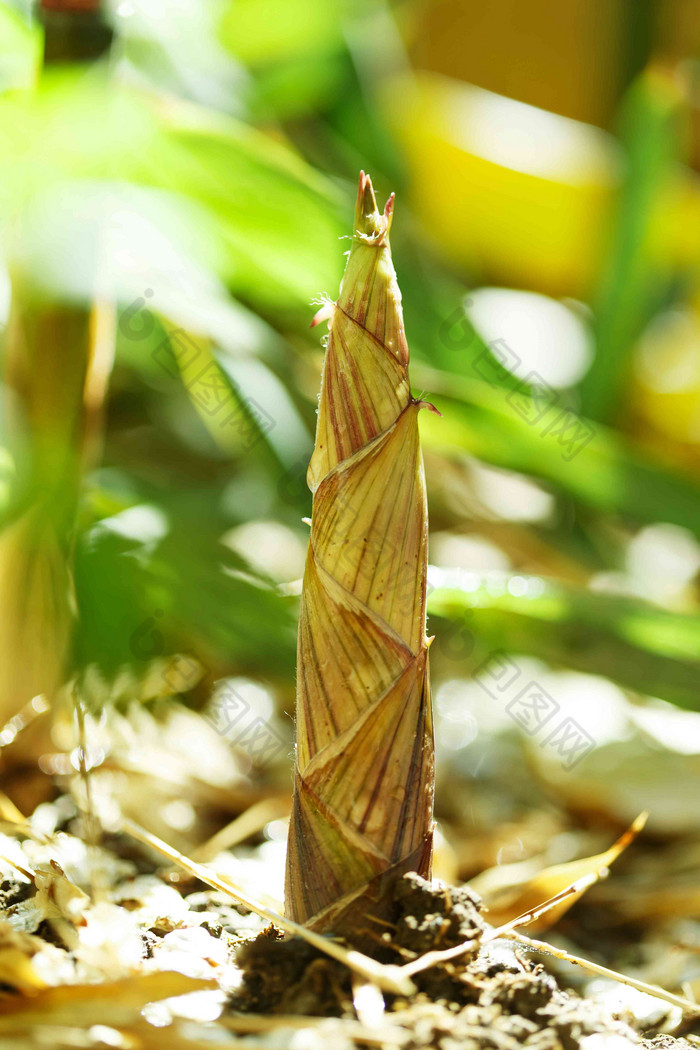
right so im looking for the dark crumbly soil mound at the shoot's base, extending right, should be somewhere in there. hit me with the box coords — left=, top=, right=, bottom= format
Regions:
left=230, top=874, right=692, bottom=1050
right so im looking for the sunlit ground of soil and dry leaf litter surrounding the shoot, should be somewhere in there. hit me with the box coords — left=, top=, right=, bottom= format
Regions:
left=0, top=714, right=700, bottom=1050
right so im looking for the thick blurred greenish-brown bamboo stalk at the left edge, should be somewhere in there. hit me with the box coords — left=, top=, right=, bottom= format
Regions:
left=0, top=271, right=113, bottom=723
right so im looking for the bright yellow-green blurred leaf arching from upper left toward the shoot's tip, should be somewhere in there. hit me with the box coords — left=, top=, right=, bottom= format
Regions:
left=0, top=67, right=341, bottom=312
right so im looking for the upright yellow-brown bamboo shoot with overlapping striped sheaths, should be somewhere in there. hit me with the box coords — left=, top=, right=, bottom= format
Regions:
left=285, top=172, right=433, bottom=931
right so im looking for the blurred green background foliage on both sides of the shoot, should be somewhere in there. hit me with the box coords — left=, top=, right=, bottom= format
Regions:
left=0, top=0, right=700, bottom=722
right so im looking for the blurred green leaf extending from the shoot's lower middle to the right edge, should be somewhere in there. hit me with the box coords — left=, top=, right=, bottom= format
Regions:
left=428, top=570, right=700, bottom=711
